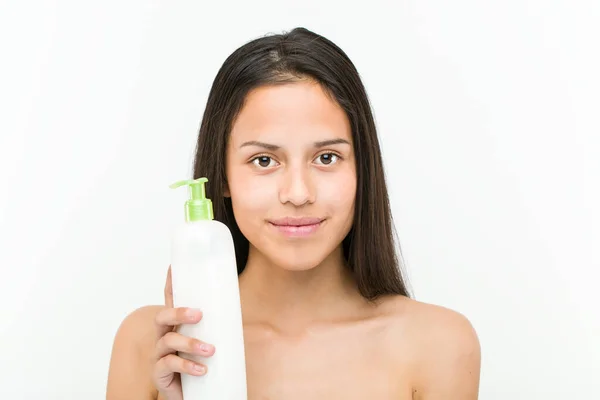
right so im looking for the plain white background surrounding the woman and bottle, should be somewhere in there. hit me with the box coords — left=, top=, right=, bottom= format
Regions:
left=0, top=0, right=600, bottom=400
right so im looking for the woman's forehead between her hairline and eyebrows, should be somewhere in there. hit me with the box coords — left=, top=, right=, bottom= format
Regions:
left=230, top=81, right=351, bottom=145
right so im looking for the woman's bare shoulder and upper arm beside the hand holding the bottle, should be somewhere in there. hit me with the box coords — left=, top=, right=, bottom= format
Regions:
left=106, top=305, right=164, bottom=400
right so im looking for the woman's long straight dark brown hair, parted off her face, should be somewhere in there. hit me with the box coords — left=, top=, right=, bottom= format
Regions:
left=194, top=27, right=410, bottom=300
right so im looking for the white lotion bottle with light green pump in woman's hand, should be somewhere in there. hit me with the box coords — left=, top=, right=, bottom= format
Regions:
left=170, top=178, right=247, bottom=400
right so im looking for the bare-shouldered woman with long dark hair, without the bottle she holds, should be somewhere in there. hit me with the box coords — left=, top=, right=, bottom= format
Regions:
left=107, top=28, right=480, bottom=400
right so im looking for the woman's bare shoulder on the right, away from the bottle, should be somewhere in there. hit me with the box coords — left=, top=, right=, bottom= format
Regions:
left=385, top=296, right=481, bottom=400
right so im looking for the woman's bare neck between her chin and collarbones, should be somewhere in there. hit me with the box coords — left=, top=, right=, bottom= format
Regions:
left=239, top=245, right=366, bottom=331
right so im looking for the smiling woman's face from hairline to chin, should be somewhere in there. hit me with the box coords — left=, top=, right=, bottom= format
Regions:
left=226, top=81, right=356, bottom=270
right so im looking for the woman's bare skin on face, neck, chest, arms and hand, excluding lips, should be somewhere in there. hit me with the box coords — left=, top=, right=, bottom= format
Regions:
left=107, top=80, right=481, bottom=400
